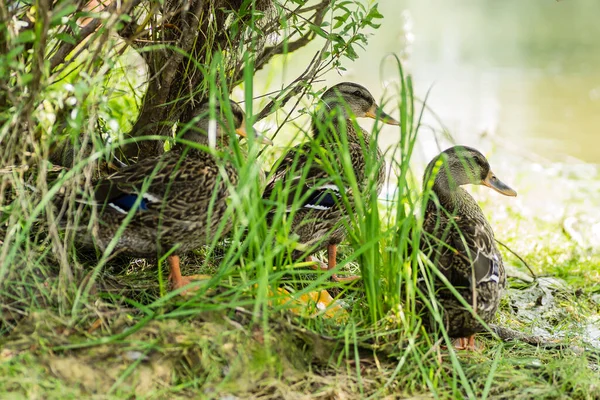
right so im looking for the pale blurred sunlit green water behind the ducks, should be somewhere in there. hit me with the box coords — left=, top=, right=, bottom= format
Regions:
left=350, top=0, right=600, bottom=163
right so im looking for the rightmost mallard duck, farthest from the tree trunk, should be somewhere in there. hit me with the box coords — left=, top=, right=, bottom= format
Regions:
left=421, top=146, right=517, bottom=349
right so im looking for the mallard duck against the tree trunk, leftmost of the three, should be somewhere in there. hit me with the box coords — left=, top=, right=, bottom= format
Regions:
left=64, top=101, right=270, bottom=289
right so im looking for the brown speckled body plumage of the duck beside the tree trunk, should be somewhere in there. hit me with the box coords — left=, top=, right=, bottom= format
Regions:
left=88, top=148, right=238, bottom=257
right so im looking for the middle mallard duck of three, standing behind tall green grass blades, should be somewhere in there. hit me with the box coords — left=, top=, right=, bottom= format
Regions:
left=263, top=82, right=399, bottom=281
